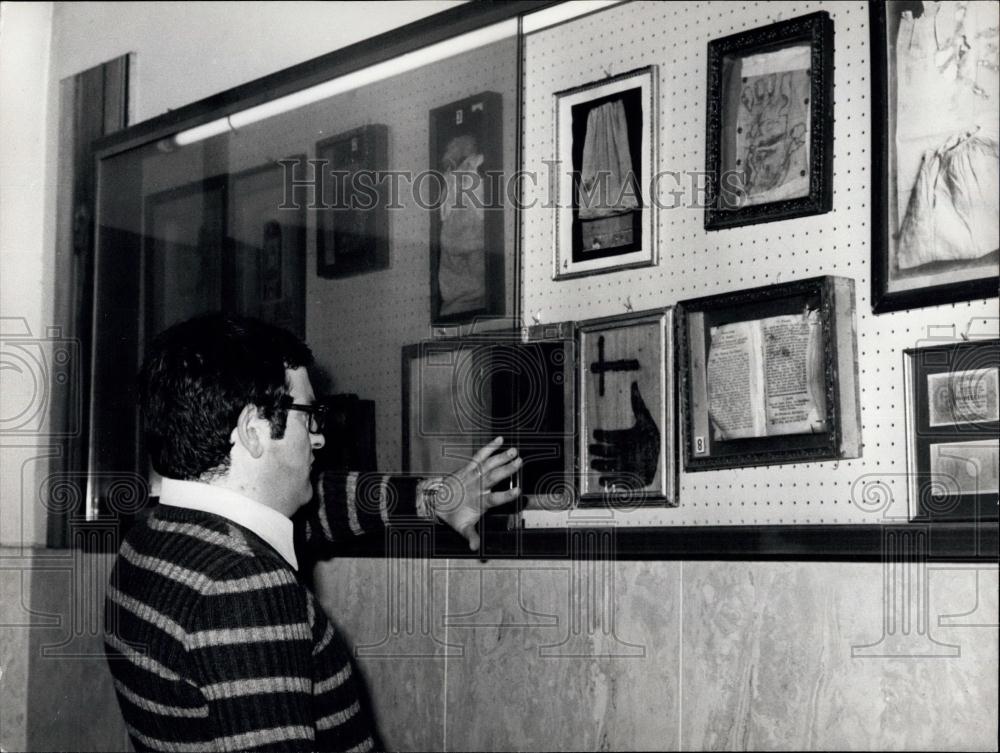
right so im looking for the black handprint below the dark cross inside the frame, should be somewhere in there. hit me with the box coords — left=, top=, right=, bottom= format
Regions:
left=590, top=382, right=660, bottom=489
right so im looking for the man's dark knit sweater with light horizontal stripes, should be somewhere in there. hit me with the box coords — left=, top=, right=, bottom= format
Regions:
left=105, top=474, right=426, bottom=751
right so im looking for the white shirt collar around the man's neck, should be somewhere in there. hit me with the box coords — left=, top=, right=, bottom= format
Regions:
left=160, top=478, right=299, bottom=570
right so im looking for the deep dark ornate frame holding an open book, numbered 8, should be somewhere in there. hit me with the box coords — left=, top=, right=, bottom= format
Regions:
left=678, top=277, right=861, bottom=471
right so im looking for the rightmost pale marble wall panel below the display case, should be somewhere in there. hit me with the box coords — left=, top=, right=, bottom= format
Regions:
left=682, top=562, right=997, bottom=750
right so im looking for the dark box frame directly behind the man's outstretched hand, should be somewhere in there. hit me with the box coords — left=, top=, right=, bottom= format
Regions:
left=402, top=335, right=573, bottom=498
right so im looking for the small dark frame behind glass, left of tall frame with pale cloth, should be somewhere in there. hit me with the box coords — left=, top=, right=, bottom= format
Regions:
left=316, top=124, right=389, bottom=277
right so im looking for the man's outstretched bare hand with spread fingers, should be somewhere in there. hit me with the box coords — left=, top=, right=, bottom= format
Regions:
left=432, top=437, right=521, bottom=551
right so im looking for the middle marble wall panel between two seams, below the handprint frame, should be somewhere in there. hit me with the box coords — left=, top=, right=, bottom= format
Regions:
left=439, top=558, right=679, bottom=750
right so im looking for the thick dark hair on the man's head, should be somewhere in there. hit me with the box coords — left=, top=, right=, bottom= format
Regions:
left=139, top=314, right=313, bottom=480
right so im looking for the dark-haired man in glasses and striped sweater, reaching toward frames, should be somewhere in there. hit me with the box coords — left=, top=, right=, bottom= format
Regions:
left=105, top=315, right=520, bottom=751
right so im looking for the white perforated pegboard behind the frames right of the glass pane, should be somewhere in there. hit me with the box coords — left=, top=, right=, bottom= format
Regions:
left=521, top=0, right=1000, bottom=526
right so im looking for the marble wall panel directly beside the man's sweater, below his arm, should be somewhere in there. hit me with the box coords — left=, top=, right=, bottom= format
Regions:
left=314, top=558, right=454, bottom=751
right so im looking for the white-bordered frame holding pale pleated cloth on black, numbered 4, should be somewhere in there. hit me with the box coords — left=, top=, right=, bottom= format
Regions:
left=553, top=66, right=659, bottom=280
